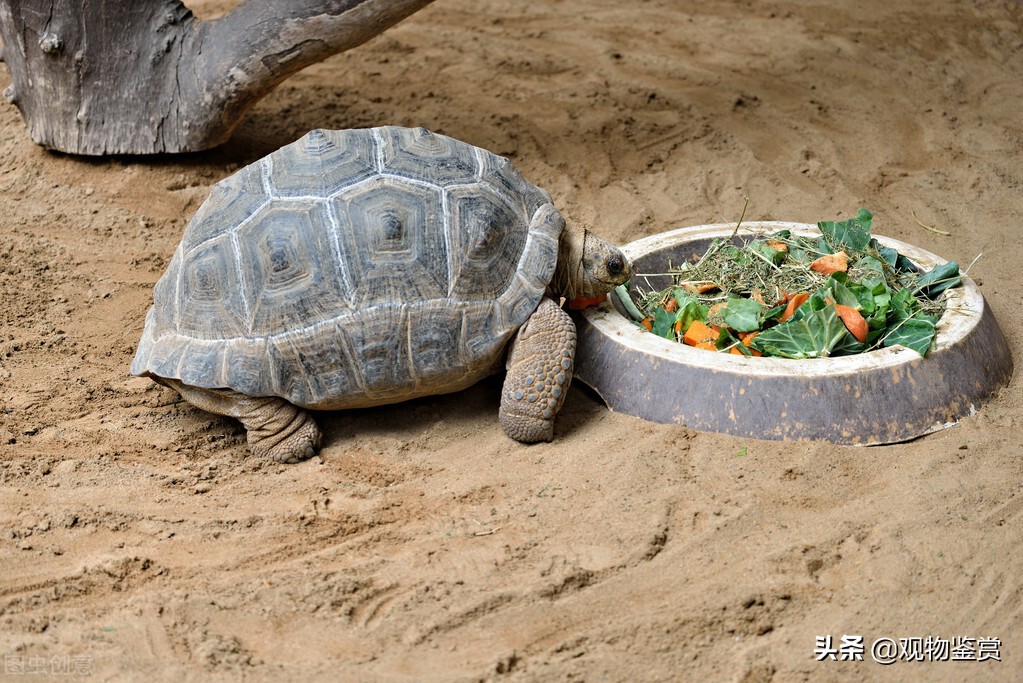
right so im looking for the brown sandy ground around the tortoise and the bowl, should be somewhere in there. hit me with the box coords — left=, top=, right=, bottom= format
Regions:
left=0, top=0, right=1023, bottom=681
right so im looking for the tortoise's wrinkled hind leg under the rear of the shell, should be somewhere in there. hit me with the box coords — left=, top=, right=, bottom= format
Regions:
left=158, top=377, right=322, bottom=462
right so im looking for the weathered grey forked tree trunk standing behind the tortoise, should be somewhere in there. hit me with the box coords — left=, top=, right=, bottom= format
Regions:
left=0, top=0, right=432, bottom=154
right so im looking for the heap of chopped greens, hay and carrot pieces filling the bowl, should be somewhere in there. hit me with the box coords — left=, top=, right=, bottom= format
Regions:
left=616, top=209, right=963, bottom=358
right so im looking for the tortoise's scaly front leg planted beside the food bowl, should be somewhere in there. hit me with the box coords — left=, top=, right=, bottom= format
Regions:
left=500, top=298, right=576, bottom=444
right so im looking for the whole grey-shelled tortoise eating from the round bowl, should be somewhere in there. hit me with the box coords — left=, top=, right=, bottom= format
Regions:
left=131, top=126, right=629, bottom=462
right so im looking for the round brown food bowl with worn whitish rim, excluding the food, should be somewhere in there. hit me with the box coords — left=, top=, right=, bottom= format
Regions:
left=574, top=222, right=1013, bottom=446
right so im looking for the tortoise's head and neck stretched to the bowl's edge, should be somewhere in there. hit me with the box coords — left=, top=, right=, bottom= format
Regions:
left=550, top=228, right=632, bottom=299
